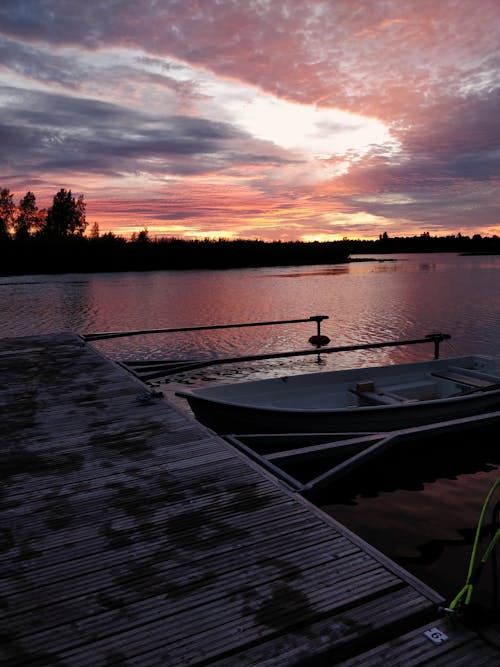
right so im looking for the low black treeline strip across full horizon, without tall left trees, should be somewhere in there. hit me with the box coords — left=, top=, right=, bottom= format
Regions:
left=0, top=233, right=500, bottom=275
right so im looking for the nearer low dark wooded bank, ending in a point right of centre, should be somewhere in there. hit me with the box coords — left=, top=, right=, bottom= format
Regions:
left=0, top=234, right=349, bottom=275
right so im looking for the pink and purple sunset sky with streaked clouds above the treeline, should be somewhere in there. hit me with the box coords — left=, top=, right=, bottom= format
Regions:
left=0, top=0, right=500, bottom=241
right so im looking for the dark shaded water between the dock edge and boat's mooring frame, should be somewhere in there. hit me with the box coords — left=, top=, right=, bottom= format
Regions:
left=323, top=428, right=500, bottom=606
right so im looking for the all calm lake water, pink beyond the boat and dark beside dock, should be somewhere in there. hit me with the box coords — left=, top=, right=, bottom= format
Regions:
left=0, top=254, right=500, bottom=612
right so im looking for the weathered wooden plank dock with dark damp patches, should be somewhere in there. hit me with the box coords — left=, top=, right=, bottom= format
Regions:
left=0, top=334, right=500, bottom=667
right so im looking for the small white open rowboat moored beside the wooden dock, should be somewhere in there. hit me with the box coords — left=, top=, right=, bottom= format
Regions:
left=176, top=355, right=500, bottom=435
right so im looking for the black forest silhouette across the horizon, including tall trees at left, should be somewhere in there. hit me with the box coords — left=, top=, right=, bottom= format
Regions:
left=0, top=188, right=500, bottom=275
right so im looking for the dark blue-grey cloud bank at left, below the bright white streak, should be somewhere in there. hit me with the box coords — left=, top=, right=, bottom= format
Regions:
left=0, top=87, right=294, bottom=175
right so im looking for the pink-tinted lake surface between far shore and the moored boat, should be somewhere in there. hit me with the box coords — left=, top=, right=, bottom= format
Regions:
left=0, top=254, right=500, bottom=365
